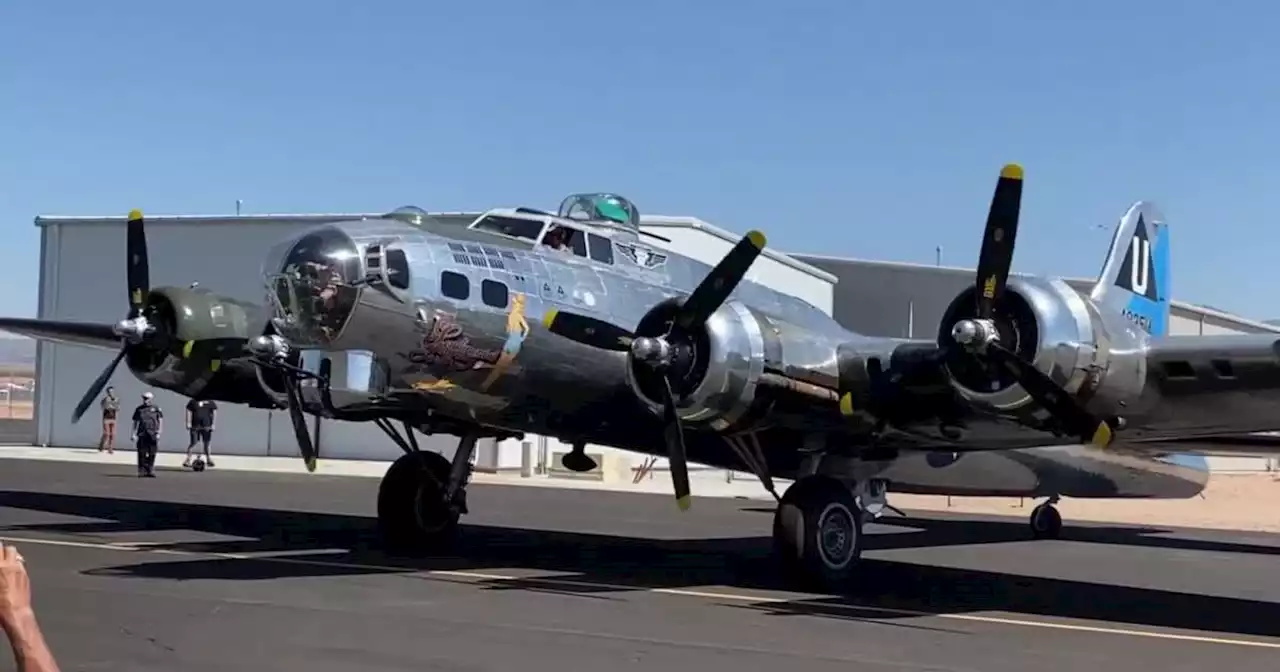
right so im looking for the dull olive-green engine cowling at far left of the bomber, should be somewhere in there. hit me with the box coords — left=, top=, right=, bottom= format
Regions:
left=124, top=287, right=284, bottom=408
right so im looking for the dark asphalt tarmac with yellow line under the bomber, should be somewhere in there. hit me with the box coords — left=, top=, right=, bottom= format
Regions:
left=0, top=453, right=1280, bottom=672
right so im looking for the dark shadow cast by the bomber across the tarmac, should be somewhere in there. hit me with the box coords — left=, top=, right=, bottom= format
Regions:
left=0, top=492, right=1280, bottom=636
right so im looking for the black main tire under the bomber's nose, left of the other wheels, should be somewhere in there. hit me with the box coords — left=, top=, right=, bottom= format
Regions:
left=378, top=451, right=461, bottom=552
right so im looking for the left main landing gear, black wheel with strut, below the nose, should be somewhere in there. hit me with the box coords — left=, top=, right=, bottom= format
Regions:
left=375, top=420, right=479, bottom=550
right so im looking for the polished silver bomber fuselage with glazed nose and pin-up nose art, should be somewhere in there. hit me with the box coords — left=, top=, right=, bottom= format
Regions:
left=249, top=212, right=1207, bottom=497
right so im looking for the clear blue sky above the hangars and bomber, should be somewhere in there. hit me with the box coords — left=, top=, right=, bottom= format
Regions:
left=0, top=0, right=1280, bottom=319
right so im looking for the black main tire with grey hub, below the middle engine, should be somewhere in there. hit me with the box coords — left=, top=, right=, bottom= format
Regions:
left=773, top=476, right=863, bottom=589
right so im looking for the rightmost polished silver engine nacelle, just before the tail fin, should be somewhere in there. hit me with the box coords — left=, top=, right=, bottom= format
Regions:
left=938, top=278, right=1147, bottom=419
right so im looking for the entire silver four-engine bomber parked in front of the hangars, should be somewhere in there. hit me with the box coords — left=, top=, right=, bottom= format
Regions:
left=0, top=165, right=1280, bottom=584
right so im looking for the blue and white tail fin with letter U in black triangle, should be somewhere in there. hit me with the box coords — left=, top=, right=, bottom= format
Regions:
left=1089, top=201, right=1170, bottom=338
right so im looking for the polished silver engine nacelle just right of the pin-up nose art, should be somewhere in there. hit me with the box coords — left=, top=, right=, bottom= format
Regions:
left=627, top=300, right=781, bottom=430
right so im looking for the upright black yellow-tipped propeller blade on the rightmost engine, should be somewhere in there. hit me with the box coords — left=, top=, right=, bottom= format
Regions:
left=977, top=164, right=1023, bottom=320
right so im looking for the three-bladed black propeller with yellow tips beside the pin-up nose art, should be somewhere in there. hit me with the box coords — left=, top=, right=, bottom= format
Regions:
left=543, top=230, right=765, bottom=511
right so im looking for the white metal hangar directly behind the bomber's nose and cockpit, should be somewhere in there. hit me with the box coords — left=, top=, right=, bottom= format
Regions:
left=33, top=212, right=835, bottom=468
